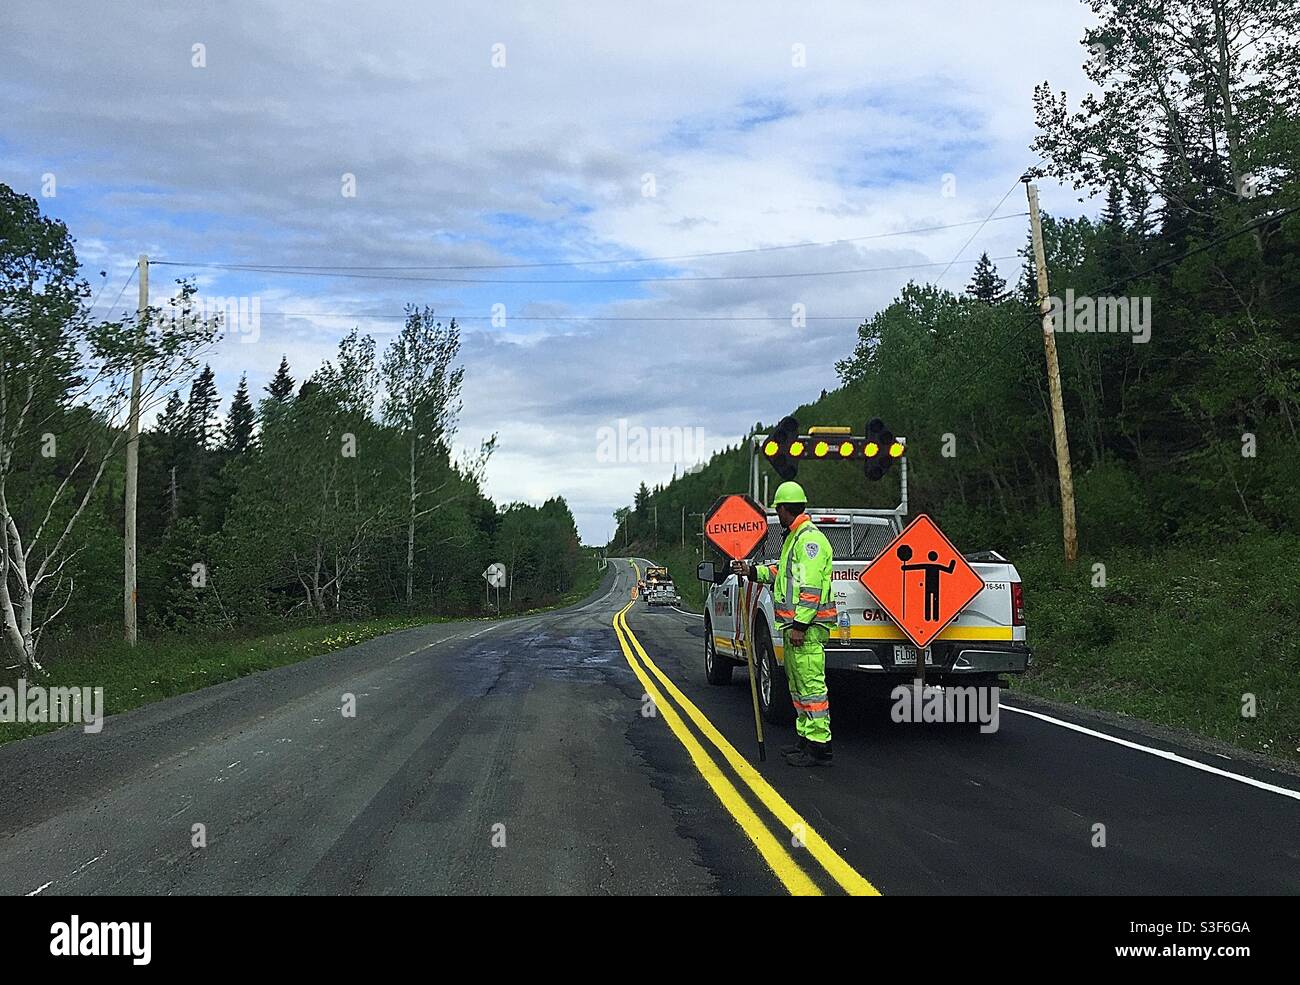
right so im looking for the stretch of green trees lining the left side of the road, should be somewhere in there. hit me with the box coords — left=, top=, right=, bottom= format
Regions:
left=0, top=185, right=595, bottom=673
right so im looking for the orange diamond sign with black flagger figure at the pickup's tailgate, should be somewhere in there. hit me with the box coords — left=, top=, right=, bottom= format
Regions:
left=858, top=513, right=984, bottom=648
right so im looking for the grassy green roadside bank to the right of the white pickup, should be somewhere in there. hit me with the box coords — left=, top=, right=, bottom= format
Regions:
left=1014, top=534, right=1300, bottom=759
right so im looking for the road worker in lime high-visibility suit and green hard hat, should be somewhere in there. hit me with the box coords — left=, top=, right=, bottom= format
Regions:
left=732, top=482, right=836, bottom=767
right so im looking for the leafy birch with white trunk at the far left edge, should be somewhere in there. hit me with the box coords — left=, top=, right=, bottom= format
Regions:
left=0, top=185, right=213, bottom=673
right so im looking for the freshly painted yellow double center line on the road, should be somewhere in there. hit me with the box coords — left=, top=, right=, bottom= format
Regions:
left=614, top=565, right=880, bottom=897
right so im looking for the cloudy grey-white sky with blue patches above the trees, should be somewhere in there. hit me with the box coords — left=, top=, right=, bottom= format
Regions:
left=0, top=0, right=1095, bottom=543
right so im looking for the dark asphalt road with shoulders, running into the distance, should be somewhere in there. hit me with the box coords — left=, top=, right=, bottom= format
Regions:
left=0, top=561, right=1300, bottom=895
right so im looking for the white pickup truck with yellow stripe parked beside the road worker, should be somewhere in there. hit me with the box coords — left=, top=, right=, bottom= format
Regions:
left=698, top=429, right=1032, bottom=725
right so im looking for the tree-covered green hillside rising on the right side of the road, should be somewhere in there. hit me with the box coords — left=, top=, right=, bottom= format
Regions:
left=611, top=0, right=1300, bottom=758
